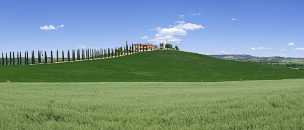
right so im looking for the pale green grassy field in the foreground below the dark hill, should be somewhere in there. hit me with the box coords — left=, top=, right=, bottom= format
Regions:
left=0, top=80, right=304, bottom=130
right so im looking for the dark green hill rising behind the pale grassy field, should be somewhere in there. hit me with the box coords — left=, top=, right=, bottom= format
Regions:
left=0, top=51, right=304, bottom=82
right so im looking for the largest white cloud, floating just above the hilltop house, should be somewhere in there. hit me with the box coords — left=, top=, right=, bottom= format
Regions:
left=151, top=21, right=206, bottom=42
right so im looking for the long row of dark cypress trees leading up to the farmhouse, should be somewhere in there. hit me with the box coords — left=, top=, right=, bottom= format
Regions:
left=0, top=43, right=153, bottom=66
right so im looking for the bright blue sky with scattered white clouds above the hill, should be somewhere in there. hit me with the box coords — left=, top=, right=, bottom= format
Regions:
left=0, top=0, right=304, bottom=57
